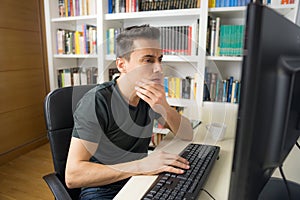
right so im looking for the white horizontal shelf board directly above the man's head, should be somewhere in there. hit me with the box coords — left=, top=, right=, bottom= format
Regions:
left=104, top=8, right=201, bottom=21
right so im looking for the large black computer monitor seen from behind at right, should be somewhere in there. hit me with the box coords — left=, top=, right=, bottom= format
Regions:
left=229, top=3, right=300, bottom=200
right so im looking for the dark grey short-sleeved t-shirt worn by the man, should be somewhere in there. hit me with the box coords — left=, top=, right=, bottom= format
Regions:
left=73, top=80, right=160, bottom=164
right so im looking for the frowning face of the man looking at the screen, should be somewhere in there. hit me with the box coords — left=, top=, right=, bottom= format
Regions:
left=126, top=39, right=163, bottom=84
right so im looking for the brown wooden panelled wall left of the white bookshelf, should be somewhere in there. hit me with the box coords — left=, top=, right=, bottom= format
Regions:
left=0, top=0, right=49, bottom=164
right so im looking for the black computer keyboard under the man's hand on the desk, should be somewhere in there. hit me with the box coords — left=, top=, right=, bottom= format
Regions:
left=142, top=144, right=220, bottom=200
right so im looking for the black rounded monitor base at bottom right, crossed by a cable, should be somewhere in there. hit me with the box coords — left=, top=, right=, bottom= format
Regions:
left=258, top=177, right=300, bottom=200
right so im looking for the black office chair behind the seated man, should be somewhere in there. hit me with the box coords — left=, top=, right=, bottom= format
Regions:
left=43, top=85, right=95, bottom=200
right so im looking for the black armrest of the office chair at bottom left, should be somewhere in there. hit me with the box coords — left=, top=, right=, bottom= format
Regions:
left=43, top=173, right=72, bottom=200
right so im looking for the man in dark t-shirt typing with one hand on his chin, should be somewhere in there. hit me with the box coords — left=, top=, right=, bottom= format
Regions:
left=65, top=25, right=193, bottom=199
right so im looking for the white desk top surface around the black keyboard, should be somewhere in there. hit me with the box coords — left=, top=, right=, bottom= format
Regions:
left=114, top=126, right=234, bottom=200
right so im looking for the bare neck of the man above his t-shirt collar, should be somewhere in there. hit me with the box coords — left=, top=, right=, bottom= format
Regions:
left=116, top=76, right=140, bottom=106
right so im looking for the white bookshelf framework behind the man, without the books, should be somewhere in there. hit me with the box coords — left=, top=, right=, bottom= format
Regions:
left=44, top=0, right=298, bottom=122
